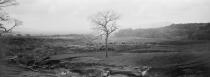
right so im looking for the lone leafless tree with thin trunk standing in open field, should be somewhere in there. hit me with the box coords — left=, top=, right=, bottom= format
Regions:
left=91, top=11, right=120, bottom=57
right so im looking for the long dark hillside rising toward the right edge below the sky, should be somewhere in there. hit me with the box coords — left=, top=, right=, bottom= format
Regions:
left=115, top=23, right=210, bottom=40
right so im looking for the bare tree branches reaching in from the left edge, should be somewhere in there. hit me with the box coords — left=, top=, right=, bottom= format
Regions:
left=0, top=0, right=22, bottom=35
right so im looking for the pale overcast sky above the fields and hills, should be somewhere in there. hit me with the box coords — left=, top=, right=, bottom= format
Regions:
left=7, top=0, right=210, bottom=34
